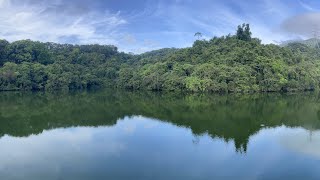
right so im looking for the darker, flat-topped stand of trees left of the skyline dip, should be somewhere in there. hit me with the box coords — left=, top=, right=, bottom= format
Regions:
left=0, top=40, right=126, bottom=91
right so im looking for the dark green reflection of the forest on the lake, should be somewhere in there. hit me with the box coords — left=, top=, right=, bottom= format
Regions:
left=0, top=91, right=320, bottom=152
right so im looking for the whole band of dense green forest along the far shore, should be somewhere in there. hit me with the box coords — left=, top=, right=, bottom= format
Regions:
left=0, top=24, right=320, bottom=92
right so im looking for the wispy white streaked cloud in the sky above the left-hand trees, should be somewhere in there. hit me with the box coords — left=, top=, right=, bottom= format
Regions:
left=0, top=0, right=127, bottom=45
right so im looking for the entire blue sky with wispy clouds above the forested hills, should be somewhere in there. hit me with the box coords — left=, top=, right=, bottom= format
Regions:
left=0, top=0, right=320, bottom=53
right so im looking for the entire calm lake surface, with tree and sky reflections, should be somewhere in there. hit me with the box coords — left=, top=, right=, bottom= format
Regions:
left=0, top=91, right=320, bottom=180
